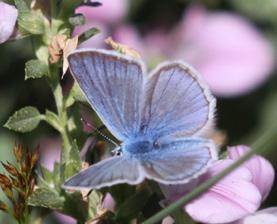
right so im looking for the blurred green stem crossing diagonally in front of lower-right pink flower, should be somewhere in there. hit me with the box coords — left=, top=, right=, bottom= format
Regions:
left=143, top=129, right=275, bottom=224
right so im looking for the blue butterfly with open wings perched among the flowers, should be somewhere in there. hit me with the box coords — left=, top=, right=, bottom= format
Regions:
left=64, top=49, right=217, bottom=189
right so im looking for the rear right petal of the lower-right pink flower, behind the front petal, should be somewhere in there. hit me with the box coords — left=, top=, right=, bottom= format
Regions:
left=228, top=145, right=275, bottom=200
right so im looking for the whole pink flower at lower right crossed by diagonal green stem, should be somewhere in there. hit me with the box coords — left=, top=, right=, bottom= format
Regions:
left=161, top=146, right=274, bottom=224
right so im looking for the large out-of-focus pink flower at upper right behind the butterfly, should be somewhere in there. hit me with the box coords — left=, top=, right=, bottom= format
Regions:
left=171, top=6, right=273, bottom=97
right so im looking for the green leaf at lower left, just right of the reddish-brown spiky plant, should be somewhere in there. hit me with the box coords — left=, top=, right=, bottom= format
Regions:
left=28, top=188, right=65, bottom=210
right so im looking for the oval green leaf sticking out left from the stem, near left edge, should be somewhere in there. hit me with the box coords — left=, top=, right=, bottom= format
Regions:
left=4, top=106, right=44, bottom=133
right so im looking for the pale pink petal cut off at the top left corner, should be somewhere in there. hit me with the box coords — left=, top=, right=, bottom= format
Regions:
left=0, top=2, right=18, bottom=43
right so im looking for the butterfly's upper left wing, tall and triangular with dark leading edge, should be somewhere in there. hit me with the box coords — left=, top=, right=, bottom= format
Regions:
left=68, top=49, right=144, bottom=141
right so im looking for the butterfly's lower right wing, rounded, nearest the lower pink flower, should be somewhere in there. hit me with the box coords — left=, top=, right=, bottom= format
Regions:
left=141, top=138, right=217, bottom=184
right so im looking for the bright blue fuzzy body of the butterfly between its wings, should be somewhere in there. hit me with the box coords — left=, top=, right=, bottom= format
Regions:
left=121, top=139, right=160, bottom=157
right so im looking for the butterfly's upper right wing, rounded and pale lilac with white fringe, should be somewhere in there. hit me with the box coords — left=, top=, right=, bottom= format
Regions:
left=141, top=62, right=215, bottom=138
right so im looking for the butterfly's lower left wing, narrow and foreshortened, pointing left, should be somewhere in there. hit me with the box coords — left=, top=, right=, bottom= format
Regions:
left=63, top=156, right=144, bottom=189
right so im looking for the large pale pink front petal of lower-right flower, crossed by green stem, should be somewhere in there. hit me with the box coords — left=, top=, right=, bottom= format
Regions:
left=185, top=160, right=261, bottom=223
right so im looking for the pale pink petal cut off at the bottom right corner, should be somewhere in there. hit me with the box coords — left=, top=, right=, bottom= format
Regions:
left=230, top=207, right=277, bottom=224
